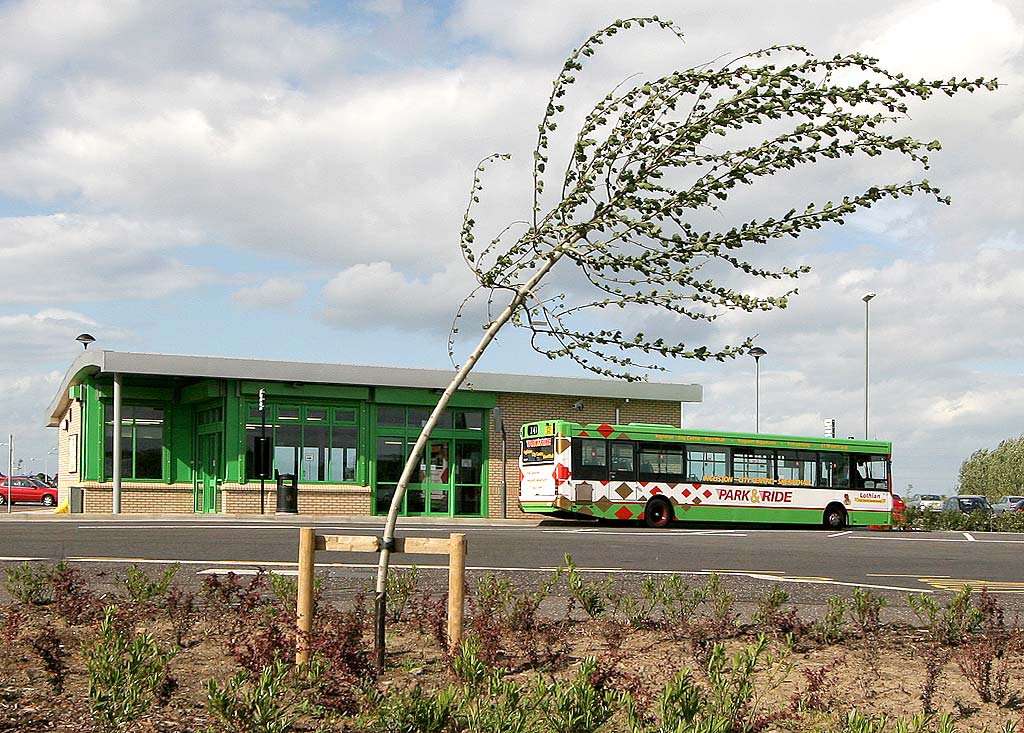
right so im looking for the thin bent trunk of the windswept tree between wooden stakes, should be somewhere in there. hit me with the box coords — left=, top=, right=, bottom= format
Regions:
left=374, top=245, right=569, bottom=671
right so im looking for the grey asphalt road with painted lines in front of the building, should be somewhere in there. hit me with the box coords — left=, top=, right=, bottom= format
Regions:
left=0, top=514, right=1024, bottom=610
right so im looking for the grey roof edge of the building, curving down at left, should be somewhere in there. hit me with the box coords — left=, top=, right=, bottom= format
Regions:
left=48, top=350, right=703, bottom=427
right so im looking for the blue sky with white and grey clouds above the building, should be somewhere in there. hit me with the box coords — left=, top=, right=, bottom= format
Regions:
left=0, top=0, right=1024, bottom=492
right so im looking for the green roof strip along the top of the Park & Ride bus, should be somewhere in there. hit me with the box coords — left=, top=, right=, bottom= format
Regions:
left=521, top=420, right=892, bottom=456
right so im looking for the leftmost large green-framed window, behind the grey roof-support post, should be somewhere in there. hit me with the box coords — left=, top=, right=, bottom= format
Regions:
left=103, top=404, right=164, bottom=479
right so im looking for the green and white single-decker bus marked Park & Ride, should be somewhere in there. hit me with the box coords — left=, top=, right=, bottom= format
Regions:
left=519, top=420, right=893, bottom=529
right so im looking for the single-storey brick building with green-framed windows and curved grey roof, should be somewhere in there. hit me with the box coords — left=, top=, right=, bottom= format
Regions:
left=49, top=350, right=701, bottom=517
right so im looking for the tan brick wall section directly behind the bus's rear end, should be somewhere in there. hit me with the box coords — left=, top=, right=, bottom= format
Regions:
left=487, top=393, right=680, bottom=519
